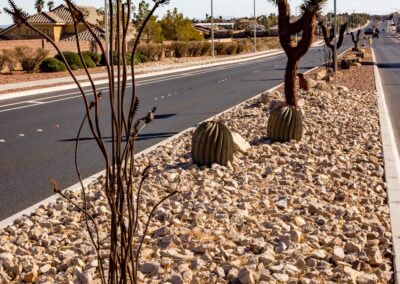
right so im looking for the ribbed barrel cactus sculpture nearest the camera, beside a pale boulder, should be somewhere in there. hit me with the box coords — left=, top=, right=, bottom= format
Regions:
left=192, top=121, right=234, bottom=167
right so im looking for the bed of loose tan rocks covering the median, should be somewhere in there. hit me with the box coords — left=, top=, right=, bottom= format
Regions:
left=0, top=47, right=393, bottom=284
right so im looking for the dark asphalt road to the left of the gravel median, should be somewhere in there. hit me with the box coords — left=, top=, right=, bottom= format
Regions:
left=0, top=38, right=351, bottom=220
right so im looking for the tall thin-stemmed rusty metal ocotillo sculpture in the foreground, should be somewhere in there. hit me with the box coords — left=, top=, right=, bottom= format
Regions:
left=4, top=0, right=176, bottom=284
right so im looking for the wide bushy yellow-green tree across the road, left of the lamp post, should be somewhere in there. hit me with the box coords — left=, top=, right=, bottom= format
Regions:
left=160, top=8, right=204, bottom=41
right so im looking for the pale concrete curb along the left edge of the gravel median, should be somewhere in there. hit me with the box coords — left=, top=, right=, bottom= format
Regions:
left=0, top=63, right=319, bottom=229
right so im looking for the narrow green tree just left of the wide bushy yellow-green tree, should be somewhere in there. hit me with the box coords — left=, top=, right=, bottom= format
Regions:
left=132, top=0, right=163, bottom=43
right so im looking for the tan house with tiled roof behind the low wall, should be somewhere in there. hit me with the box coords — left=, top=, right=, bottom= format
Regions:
left=0, top=5, right=104, bottom=42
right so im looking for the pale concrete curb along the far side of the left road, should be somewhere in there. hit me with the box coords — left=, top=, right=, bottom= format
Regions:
left=0, top=51, right=283, bottom=101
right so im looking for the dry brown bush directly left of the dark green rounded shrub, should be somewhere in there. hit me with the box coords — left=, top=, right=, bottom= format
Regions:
left=15, top=46, right=49, bottom=73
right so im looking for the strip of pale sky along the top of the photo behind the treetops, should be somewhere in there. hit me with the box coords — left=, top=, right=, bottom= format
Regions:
left=0, top=0, right=400, bottom=25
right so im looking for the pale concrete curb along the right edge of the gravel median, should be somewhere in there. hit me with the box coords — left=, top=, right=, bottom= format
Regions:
left=372, top=49, right=400, bottom=283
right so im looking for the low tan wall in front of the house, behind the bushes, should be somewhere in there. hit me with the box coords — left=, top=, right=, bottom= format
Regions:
left=0, top=39, right=104, bottom=56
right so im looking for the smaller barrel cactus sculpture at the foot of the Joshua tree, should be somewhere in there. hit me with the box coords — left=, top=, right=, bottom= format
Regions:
left=268, top=106, right=303, bottom=142
